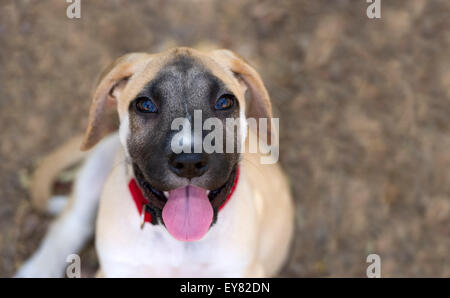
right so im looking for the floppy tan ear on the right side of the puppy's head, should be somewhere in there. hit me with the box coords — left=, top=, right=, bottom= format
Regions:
left=211, top=49, right=272, bottom=144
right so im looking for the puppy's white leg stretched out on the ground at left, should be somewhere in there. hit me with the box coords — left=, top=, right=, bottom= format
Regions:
left=16, top=134, right=120, bottom=277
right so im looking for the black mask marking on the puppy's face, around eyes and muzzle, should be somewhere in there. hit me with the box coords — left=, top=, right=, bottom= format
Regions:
left=127, top=55, right=240, bottom=222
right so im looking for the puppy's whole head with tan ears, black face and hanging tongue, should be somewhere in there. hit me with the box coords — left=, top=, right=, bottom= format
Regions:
left=82, top=48, right=271, bottom=241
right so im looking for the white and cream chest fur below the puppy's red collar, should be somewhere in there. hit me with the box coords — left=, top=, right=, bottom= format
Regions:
left=96, top=154, right=258, bottom=277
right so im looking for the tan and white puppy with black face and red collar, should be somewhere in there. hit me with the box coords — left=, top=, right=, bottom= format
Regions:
left=17, top=48, right=294, bottom=277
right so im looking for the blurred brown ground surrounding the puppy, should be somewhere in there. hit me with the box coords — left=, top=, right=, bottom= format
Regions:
left=0, top=0, right=450, bottom=277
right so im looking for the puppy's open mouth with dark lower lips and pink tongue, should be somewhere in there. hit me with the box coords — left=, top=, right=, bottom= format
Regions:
left=133, top=165, right=237, bottom=241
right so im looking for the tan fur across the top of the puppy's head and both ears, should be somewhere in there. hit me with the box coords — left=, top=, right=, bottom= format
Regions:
left=82, top=47, right=264, bottom=150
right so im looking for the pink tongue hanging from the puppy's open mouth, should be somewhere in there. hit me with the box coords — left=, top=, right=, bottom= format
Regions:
left=162, top=185, right=214, bottom=241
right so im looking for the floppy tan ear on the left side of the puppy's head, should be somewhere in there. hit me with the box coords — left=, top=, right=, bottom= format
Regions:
left=81, top=53, right=150, bottom=151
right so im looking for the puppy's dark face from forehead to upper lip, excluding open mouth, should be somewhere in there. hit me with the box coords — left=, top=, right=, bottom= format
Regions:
left=126, top=54, right=240, bottom=192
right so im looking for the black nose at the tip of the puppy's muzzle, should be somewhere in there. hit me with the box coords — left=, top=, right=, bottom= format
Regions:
left=169, top=153, right=208, bottom=179
